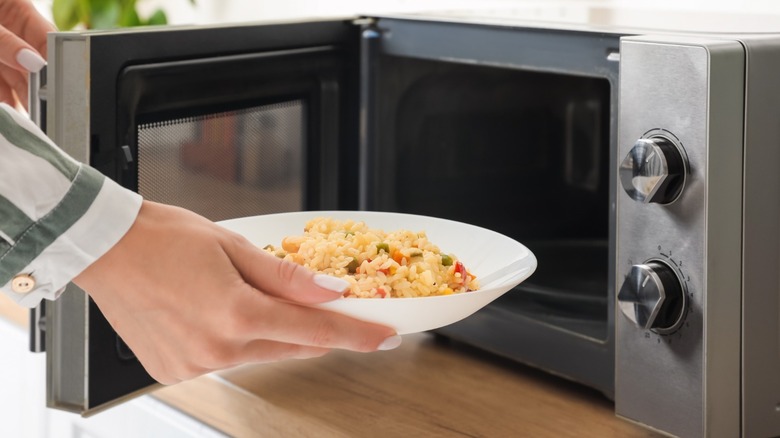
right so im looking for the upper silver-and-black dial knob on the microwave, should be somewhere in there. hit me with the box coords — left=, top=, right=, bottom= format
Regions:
left=620, top=137, right=688, bottom=204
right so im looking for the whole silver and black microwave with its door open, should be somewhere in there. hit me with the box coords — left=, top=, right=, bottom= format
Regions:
left=30, top=2, right=780, bottom=437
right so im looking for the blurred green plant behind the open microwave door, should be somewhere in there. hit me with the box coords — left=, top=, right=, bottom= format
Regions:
left=52, top=0, right=195, bottom=30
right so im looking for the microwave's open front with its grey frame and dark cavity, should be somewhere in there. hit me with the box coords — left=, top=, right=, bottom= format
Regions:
left=361, top=20, right=618, bottom=398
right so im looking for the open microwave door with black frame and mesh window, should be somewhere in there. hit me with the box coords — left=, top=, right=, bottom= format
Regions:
left=40, top=19, right=361, bottom=415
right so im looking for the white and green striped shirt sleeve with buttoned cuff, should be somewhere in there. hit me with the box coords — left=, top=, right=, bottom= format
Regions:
left=0, top=103, right=142, bottom=307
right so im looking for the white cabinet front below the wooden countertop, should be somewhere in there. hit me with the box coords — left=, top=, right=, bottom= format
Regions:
left=0, top=317, right=225, bottom=438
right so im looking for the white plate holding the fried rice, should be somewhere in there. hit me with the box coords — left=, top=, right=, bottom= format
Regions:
left=219, top=211, right=536, bottom=335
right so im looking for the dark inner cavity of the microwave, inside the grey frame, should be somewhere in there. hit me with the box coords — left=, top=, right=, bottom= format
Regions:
left=375, top=57, right=611, bottom=341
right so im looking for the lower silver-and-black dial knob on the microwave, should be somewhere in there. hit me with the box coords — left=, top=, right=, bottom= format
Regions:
left=617, top=260, right=686, bottom=334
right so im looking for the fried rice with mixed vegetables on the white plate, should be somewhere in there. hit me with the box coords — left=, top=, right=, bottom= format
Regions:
left=263, top=217, right=479, bottom=298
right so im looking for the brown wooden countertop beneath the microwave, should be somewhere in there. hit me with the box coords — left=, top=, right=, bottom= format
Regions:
left=153, top=333, right=660, bottom=438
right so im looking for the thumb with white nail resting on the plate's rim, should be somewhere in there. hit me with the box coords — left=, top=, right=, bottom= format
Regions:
left=226, top=235, right=349, bottom=304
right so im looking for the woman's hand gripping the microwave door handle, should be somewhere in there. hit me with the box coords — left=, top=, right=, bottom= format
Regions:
left=0, top=0, right=55, bottom=108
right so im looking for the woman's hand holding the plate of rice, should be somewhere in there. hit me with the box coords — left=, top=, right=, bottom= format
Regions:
left=74, top=201, right=401, bottom=384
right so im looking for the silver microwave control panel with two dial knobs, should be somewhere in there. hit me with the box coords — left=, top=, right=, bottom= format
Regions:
left=615, top=36, right=745, bottom=437
